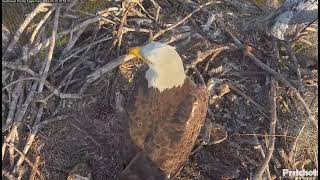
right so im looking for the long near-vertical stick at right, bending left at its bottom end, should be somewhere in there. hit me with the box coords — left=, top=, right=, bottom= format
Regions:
left=253, top=78, right=277, bottom=180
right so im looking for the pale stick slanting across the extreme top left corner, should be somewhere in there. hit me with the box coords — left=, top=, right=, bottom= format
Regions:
left=3, top=3, right=52, bottom=56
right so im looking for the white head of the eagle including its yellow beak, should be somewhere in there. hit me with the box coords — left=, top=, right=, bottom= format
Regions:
left=129, top=42, right=186, bottom=92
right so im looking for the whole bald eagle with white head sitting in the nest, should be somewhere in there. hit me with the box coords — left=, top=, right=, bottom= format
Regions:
left=119, top=42, right=208, bottom=180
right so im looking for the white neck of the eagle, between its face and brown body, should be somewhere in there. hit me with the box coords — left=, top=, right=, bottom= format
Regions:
left=146, top=62, right=186, bottom=92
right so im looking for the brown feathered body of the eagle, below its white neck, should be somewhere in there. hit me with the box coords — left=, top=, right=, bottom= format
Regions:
left=121, top=68, right=208, bottom=180
